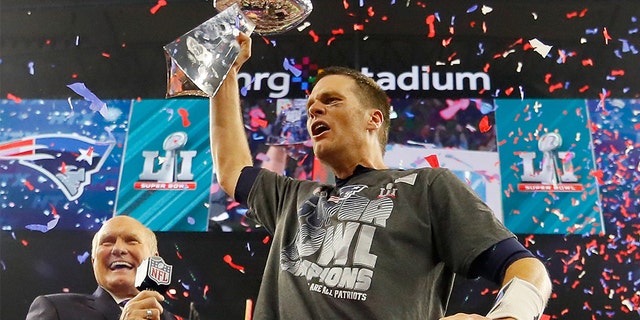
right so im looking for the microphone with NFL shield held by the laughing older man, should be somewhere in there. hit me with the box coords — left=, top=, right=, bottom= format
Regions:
left=135, top=256, right=173, bottom=294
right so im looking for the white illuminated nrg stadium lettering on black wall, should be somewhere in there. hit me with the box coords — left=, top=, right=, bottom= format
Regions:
left=238, top=65, right=491, bottom=99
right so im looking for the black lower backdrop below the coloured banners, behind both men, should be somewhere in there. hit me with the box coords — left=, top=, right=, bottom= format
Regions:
left=0, top=231, right=640, bottom=320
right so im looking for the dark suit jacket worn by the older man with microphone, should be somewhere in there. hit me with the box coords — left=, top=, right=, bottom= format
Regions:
left=26, top=287, right=176, bottom=320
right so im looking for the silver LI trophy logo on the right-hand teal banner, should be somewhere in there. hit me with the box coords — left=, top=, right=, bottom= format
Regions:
left=516, top=132, right=584, bottom=192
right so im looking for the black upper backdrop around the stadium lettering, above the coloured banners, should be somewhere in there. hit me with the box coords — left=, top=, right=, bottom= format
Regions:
left=0, top=0, right=640, bottom=99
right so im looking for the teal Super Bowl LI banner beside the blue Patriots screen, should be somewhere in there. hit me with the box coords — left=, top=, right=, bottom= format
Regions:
left=116, top=99, right=213, bottom=231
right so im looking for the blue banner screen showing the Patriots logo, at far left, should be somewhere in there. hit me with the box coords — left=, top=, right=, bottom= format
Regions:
left=0, top=99, right=132, bottom=232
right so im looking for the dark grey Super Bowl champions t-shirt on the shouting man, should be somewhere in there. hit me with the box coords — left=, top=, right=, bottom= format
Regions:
left=239, top=167, right=514, bottom=320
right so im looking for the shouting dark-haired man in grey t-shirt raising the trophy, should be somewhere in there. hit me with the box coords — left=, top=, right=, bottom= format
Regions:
left=171, top=1, right=551, bottom=320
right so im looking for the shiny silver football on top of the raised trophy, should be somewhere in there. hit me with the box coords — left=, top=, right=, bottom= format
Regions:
left=213, top=0, right=313, bottom=36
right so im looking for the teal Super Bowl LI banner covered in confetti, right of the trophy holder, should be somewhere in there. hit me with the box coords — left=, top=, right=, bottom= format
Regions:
left=495, top=99, right=604, bottom=234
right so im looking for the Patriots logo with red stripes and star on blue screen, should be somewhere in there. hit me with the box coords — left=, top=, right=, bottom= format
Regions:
left=0, top=134, right=116, bottom=201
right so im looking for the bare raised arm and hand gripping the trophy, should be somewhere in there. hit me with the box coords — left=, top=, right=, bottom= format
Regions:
left=209, top=34, right=253, bottom=196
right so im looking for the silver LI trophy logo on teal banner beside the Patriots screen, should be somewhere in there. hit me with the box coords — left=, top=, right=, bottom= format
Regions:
left=134, top=131, right=197, bottom=190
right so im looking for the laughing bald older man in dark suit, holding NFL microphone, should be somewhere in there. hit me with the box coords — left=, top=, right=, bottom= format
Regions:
left=26, top=216, right=176, bottom=320
